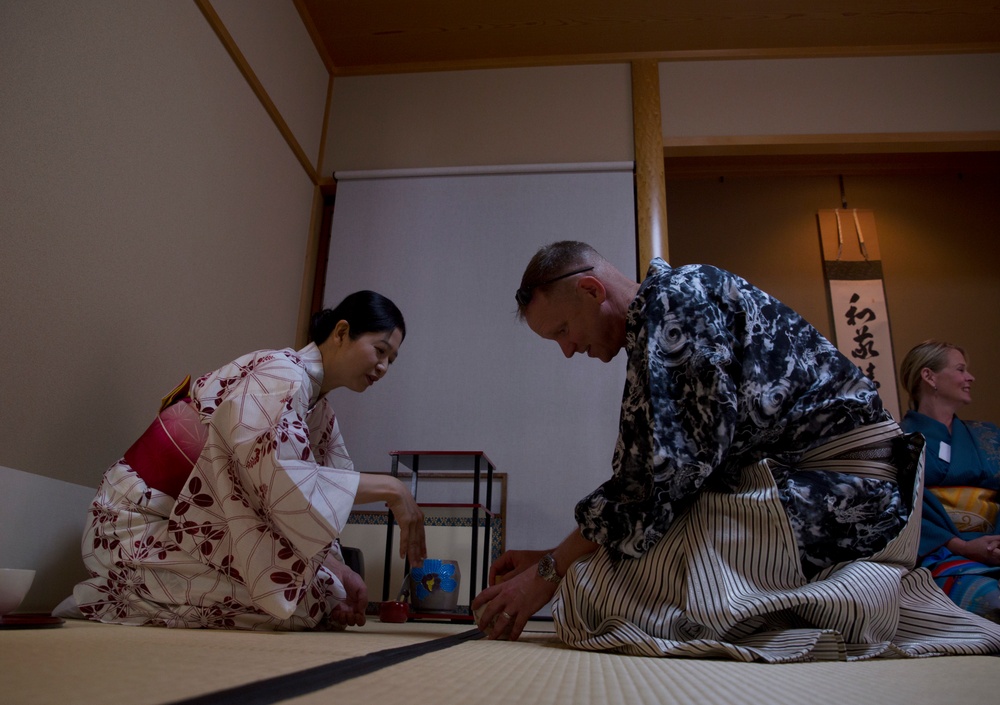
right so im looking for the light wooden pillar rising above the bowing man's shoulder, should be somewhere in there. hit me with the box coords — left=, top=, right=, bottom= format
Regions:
left=632, top=59, right=668, bottom=281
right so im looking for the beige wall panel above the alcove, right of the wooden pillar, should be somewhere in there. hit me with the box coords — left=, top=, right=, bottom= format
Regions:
left=660, top=54, right=1000, bottom=138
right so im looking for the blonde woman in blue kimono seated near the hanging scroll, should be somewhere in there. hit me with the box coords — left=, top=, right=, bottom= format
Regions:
left=900, top=340, right=1000, bottom=622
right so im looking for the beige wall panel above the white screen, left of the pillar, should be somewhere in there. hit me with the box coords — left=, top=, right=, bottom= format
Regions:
left=324, top=64, right=633, bottom=175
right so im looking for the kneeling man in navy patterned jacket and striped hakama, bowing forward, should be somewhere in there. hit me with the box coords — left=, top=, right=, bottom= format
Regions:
left=473, top=242, right=1000, bottom=661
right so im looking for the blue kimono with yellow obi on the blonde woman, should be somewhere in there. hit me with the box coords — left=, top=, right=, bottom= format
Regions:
left=902, top=411, right=1000, bottom=621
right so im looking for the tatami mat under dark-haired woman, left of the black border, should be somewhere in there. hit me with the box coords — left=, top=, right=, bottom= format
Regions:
left=0, top=620, right=470, bottom=705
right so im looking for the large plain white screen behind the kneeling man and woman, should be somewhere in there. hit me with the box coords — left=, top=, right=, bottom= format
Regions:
left=325, top=163, right=636, bottom=572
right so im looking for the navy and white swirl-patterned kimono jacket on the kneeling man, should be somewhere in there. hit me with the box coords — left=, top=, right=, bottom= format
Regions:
left=576, top=259, right=909, bottom=575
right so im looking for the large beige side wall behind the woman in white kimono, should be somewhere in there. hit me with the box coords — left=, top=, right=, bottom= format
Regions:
left=0, top=0, right=327, bottom=487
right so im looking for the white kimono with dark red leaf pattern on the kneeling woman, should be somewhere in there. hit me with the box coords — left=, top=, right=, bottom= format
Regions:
left=73, top=344, right=359, bottom=630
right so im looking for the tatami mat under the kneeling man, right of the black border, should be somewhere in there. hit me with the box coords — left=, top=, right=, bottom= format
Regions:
left=288, top=637, right=1000, bottom=705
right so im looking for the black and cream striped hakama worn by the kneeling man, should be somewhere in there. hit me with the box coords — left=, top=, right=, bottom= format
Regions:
left=552, top=421, right=1000, bottom=663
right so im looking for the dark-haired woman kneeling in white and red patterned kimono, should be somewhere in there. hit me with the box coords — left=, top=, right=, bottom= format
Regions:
left=58, top=291, right=426, bottom=630
